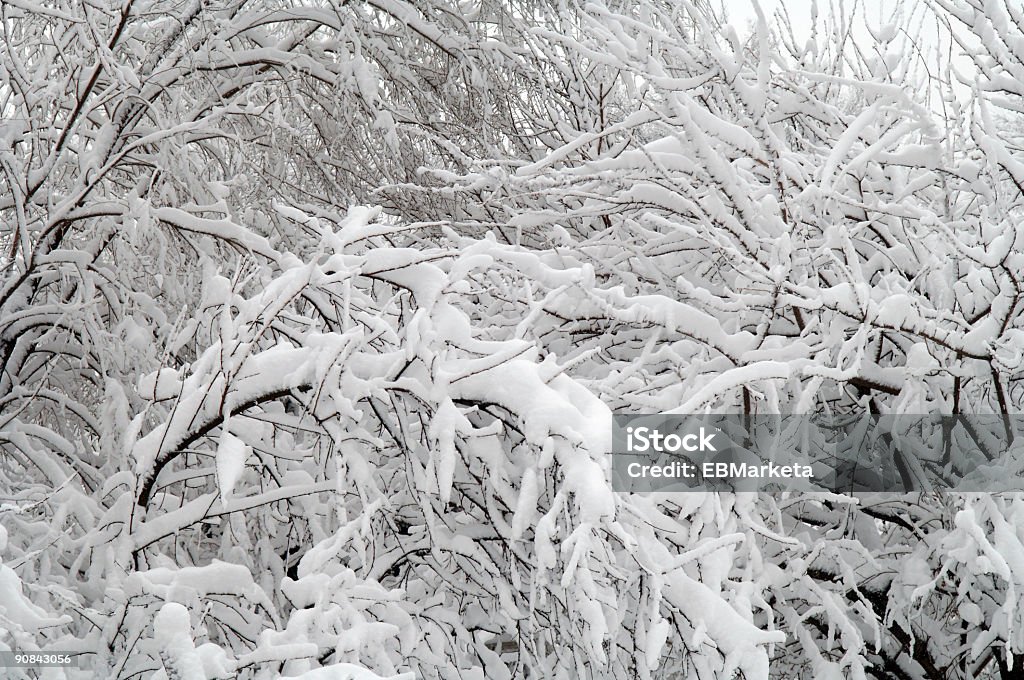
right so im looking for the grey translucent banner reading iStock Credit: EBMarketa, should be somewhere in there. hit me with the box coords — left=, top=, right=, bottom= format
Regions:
left=612, top=414, right=1024, bottom=493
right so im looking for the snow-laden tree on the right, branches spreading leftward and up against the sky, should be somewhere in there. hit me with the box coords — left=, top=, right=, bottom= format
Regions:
left=399, top=3, right=1024, bottom=678
